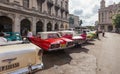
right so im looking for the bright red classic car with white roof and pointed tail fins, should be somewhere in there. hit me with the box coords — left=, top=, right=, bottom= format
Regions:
left=29, top=32, right=74, bottom=51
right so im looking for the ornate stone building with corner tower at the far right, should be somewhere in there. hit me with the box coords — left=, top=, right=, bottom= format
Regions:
left=98, top=0, right=120, bottom=32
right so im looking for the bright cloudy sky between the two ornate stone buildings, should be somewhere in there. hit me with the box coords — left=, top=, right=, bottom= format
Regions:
left=69, top=0, right=120, bottom=26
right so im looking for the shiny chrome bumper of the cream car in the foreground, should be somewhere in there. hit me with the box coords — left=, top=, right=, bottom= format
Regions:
left=8, top=63, right=43, bottom=74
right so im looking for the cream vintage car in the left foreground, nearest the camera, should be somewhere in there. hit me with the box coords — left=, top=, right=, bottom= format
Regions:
left=0, top=38, right=43, bottom=74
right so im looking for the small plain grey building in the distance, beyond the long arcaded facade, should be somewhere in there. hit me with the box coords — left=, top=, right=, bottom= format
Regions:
left=68, top=14, right=80, bottom=28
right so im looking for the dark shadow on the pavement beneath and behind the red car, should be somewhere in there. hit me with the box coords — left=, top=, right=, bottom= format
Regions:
left=43, top=47, right=89, bottom=70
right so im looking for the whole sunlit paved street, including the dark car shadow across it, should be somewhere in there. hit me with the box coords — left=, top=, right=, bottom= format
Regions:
left=36, top=33, right=120, bottom=74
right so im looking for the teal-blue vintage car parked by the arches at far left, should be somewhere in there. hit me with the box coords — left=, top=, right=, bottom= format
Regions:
left=5, top=32, right=22, bottom=41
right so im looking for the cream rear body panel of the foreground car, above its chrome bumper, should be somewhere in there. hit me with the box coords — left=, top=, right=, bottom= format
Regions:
left=0, top=43, right=40, bottom=74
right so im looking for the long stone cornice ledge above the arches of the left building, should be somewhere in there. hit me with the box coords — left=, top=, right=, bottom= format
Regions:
left=0, top=3, right=68, bottom=23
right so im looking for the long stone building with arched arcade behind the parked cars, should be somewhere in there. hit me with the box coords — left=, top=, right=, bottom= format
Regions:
left=0, top=0, right=69, bottom=35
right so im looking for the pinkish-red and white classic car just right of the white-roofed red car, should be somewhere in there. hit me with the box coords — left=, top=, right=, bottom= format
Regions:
left=58, top=31, right=85, bottom=45
